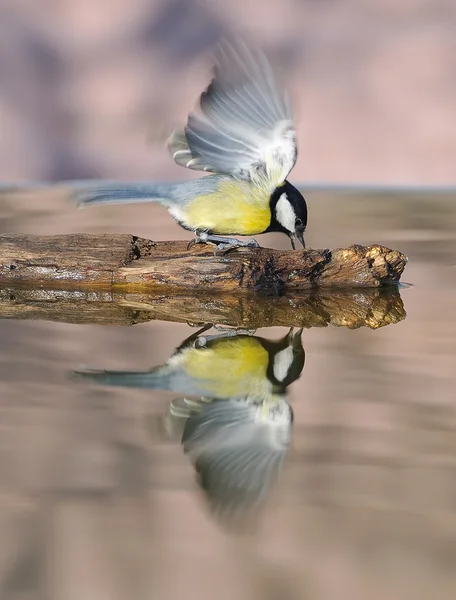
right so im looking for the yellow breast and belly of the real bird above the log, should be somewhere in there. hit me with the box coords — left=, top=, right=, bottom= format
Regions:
left=185, top=180, right=271, bottom=235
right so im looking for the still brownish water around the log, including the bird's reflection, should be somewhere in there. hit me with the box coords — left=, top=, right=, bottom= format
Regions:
left=0, top=188, right=456, bottom=600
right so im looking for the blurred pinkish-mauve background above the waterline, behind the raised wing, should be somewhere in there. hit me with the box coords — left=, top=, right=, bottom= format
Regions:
left=0, top=0, right=456, bottom=184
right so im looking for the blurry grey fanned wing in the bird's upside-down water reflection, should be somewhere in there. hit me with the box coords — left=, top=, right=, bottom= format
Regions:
left=182, top=396, right=292, bottom=520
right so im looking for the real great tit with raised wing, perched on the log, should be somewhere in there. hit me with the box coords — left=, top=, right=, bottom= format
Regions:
left=73, top=40, right=307, bottom=251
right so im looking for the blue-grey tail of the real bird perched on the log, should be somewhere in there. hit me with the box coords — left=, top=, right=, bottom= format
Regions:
left=71, top=181, right=176, bottom=208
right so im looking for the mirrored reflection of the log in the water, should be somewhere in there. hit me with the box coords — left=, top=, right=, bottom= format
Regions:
left=0, top=287, right=405, bottom=329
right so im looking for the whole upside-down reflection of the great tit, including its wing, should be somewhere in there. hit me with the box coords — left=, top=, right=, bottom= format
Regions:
left=75, top=325, right=305, bottom=525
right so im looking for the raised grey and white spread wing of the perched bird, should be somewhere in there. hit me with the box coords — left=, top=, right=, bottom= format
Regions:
left=168, top=42, right=297, bottom=187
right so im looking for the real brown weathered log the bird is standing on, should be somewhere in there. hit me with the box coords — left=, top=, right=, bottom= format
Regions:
left=0, top=234, right=407, bottom=295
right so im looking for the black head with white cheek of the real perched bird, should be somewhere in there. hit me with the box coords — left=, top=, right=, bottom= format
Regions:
left=266, top=181, right=307, bottom=248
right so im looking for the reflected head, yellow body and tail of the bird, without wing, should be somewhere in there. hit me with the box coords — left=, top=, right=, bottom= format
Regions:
left=75, top=326, right=305, bottom=398
